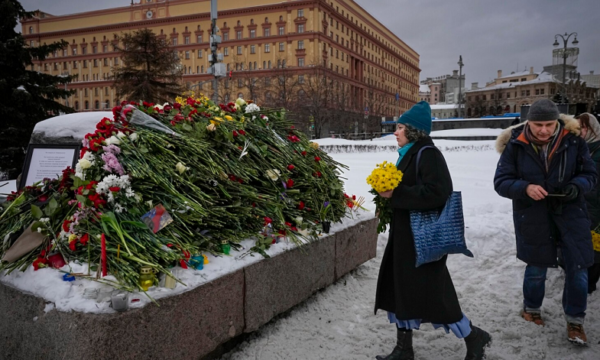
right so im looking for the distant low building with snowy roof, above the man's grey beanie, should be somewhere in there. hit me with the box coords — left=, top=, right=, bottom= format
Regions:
left=465, top=67, right=597, bottom=117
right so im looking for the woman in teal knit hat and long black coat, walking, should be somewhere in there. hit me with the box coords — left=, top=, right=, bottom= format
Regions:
left=375, top=101, right=491, bottom=360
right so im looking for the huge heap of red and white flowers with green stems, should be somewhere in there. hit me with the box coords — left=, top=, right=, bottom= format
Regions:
left=0, top=94, right=356, bottom=290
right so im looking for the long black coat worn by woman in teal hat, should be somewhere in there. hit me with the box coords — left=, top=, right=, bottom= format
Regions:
left=375, top=138, right=462, bottom=324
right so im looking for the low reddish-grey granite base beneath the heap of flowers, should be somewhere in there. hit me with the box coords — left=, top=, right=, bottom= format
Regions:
left=0, top=219, right=378, bottom=360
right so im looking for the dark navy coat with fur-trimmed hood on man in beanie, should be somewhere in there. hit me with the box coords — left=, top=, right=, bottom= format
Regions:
left=494, top=116, right=597, bottom=270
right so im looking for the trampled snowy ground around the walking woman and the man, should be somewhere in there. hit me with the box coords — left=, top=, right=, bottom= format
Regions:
left=222, top=140, right=600, bottom=360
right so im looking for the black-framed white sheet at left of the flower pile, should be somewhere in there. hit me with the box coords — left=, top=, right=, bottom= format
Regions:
left=19, top=144, right=80, bottom=189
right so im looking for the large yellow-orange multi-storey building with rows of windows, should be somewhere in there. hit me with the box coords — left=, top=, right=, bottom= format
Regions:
left=22, top=0, right=420, bottom=121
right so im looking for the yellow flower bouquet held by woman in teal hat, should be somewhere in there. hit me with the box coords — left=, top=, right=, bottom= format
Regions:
left=367, top=161, right=403, bottom=233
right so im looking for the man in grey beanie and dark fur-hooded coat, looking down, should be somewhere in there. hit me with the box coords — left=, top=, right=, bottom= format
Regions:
left=494, top=99, right=597, bottom=345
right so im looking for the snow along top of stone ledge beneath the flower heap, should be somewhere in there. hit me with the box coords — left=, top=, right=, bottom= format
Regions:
left=0, top=211, right=374, bottom=314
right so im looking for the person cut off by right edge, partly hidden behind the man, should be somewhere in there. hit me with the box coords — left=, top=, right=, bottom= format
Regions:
left=577, top=113, right=600, bottom=294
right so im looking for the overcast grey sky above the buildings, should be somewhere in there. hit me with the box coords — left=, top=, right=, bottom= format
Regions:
left=21, top=0, right=600, bottom=86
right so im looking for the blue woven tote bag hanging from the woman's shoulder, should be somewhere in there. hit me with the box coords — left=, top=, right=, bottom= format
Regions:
left=410, top=146, right=473, bottom=267
